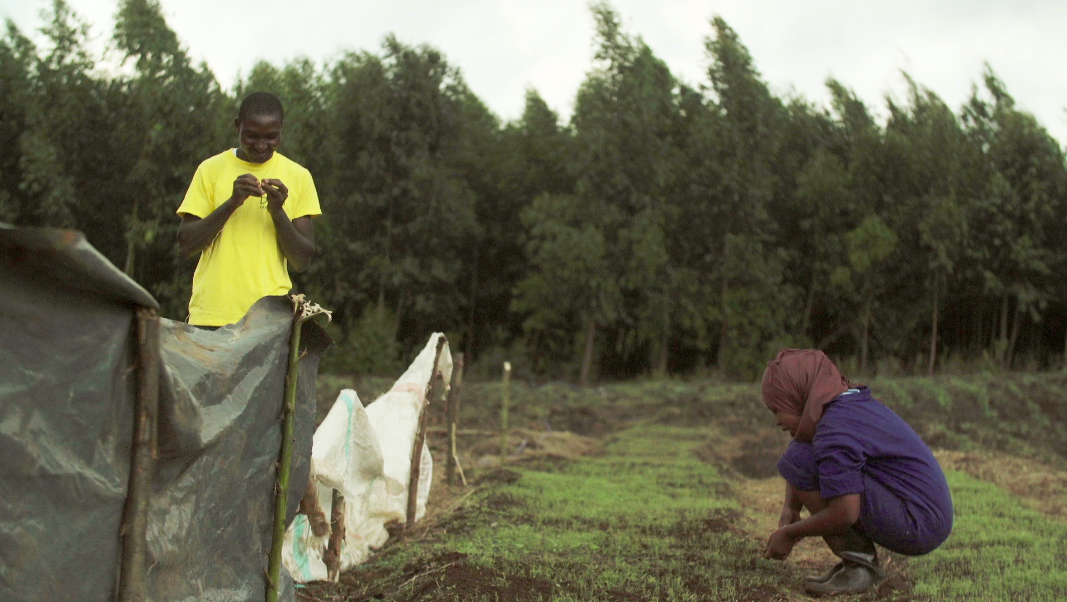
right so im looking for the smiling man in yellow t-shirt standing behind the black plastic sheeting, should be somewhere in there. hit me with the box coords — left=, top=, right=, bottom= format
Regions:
left=177, top=92, right=321, bottom=327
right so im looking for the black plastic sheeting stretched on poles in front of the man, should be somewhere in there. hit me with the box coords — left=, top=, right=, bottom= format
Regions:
left=0, top=226, right=330, bottom=602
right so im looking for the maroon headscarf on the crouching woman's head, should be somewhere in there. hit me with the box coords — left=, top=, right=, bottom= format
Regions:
left=761, top=349, right=851, bottom=441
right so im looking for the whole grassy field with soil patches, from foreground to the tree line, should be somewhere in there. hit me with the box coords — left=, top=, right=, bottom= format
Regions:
left=299, top=373, right=1067, bottom=602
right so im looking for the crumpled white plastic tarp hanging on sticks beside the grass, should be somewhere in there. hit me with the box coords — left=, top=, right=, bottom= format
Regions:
left=282, top=333, right=452, bottom=582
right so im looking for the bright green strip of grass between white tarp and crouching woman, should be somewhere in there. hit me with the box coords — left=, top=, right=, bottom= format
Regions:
left=305, top=425, right=782, bottom=602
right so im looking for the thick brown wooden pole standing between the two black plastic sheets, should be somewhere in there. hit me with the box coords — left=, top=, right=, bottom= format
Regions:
left=118, top=307, right=160, bottom=602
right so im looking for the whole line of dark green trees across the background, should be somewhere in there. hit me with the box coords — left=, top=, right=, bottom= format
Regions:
left=0, top=0, right=1067, bottom=382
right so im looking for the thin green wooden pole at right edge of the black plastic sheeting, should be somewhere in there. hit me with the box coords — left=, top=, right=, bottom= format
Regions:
left=267, top=307, right=303, bottom=602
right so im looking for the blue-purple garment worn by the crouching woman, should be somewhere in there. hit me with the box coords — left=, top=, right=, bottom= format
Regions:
left=778, top=386, right=953, bottom=556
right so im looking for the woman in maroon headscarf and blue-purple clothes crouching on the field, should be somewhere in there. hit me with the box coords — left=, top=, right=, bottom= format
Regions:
left=762, top=349, right=952, bottom=596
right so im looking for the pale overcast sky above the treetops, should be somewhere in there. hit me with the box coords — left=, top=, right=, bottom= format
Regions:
left=8, top=0, right=1067, bottom=145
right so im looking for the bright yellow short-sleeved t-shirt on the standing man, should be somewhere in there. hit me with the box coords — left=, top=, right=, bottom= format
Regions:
left=177, top=149, right=321, bottom=326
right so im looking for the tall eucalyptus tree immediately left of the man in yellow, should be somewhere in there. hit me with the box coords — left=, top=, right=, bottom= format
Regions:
left=111, top=0, right=228, bottom=309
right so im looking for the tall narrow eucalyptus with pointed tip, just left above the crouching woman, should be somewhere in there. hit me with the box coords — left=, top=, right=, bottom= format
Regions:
left=705, top=16, right=797, bottom=374
